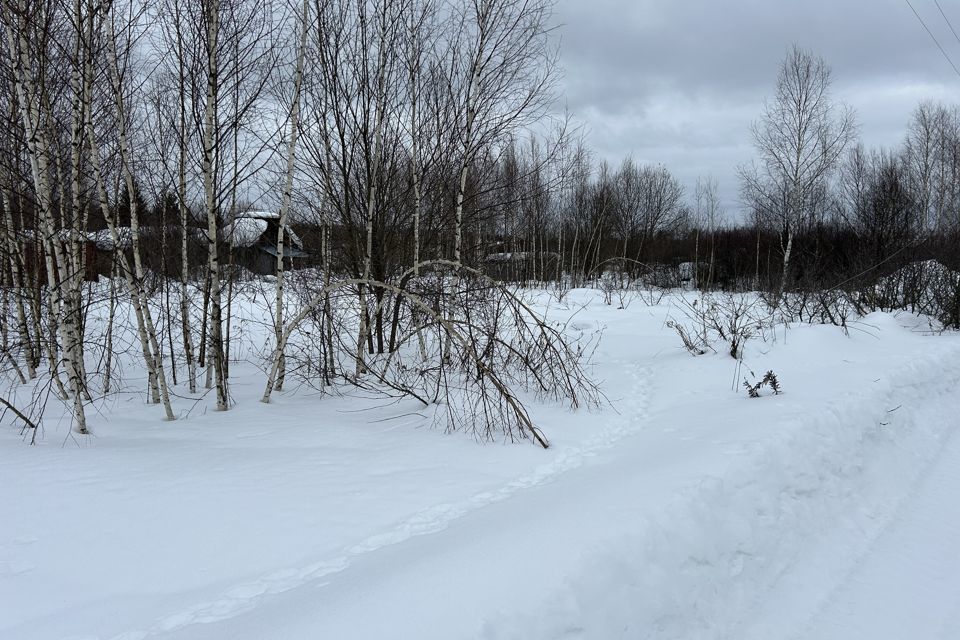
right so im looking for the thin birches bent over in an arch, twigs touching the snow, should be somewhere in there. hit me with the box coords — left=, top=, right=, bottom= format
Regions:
left=264, top=261, right=600, bottom=447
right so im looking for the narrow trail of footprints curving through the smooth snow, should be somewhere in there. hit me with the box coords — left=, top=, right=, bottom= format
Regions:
left=112, top=362, right=653, bottom=640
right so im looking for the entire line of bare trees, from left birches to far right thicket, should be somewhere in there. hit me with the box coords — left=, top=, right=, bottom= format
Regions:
left=0, top=0, right=960, bottom=438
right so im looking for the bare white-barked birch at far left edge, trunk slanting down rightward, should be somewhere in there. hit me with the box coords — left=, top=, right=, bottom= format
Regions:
left=0, top=0, right=88, bottom=433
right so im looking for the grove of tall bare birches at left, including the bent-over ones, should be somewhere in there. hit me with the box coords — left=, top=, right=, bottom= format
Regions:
left=0, top=0, right=604, bottom=446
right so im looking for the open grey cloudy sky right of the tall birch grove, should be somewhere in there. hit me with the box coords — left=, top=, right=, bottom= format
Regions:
left=556, top=0, right=960, bottom=218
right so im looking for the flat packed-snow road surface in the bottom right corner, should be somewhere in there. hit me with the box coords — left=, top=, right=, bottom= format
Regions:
left=730, top=397, right=960, bottom=640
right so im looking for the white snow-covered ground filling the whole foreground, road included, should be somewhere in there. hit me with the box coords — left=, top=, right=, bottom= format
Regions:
left=0, top=290, right=960, bottom=640
